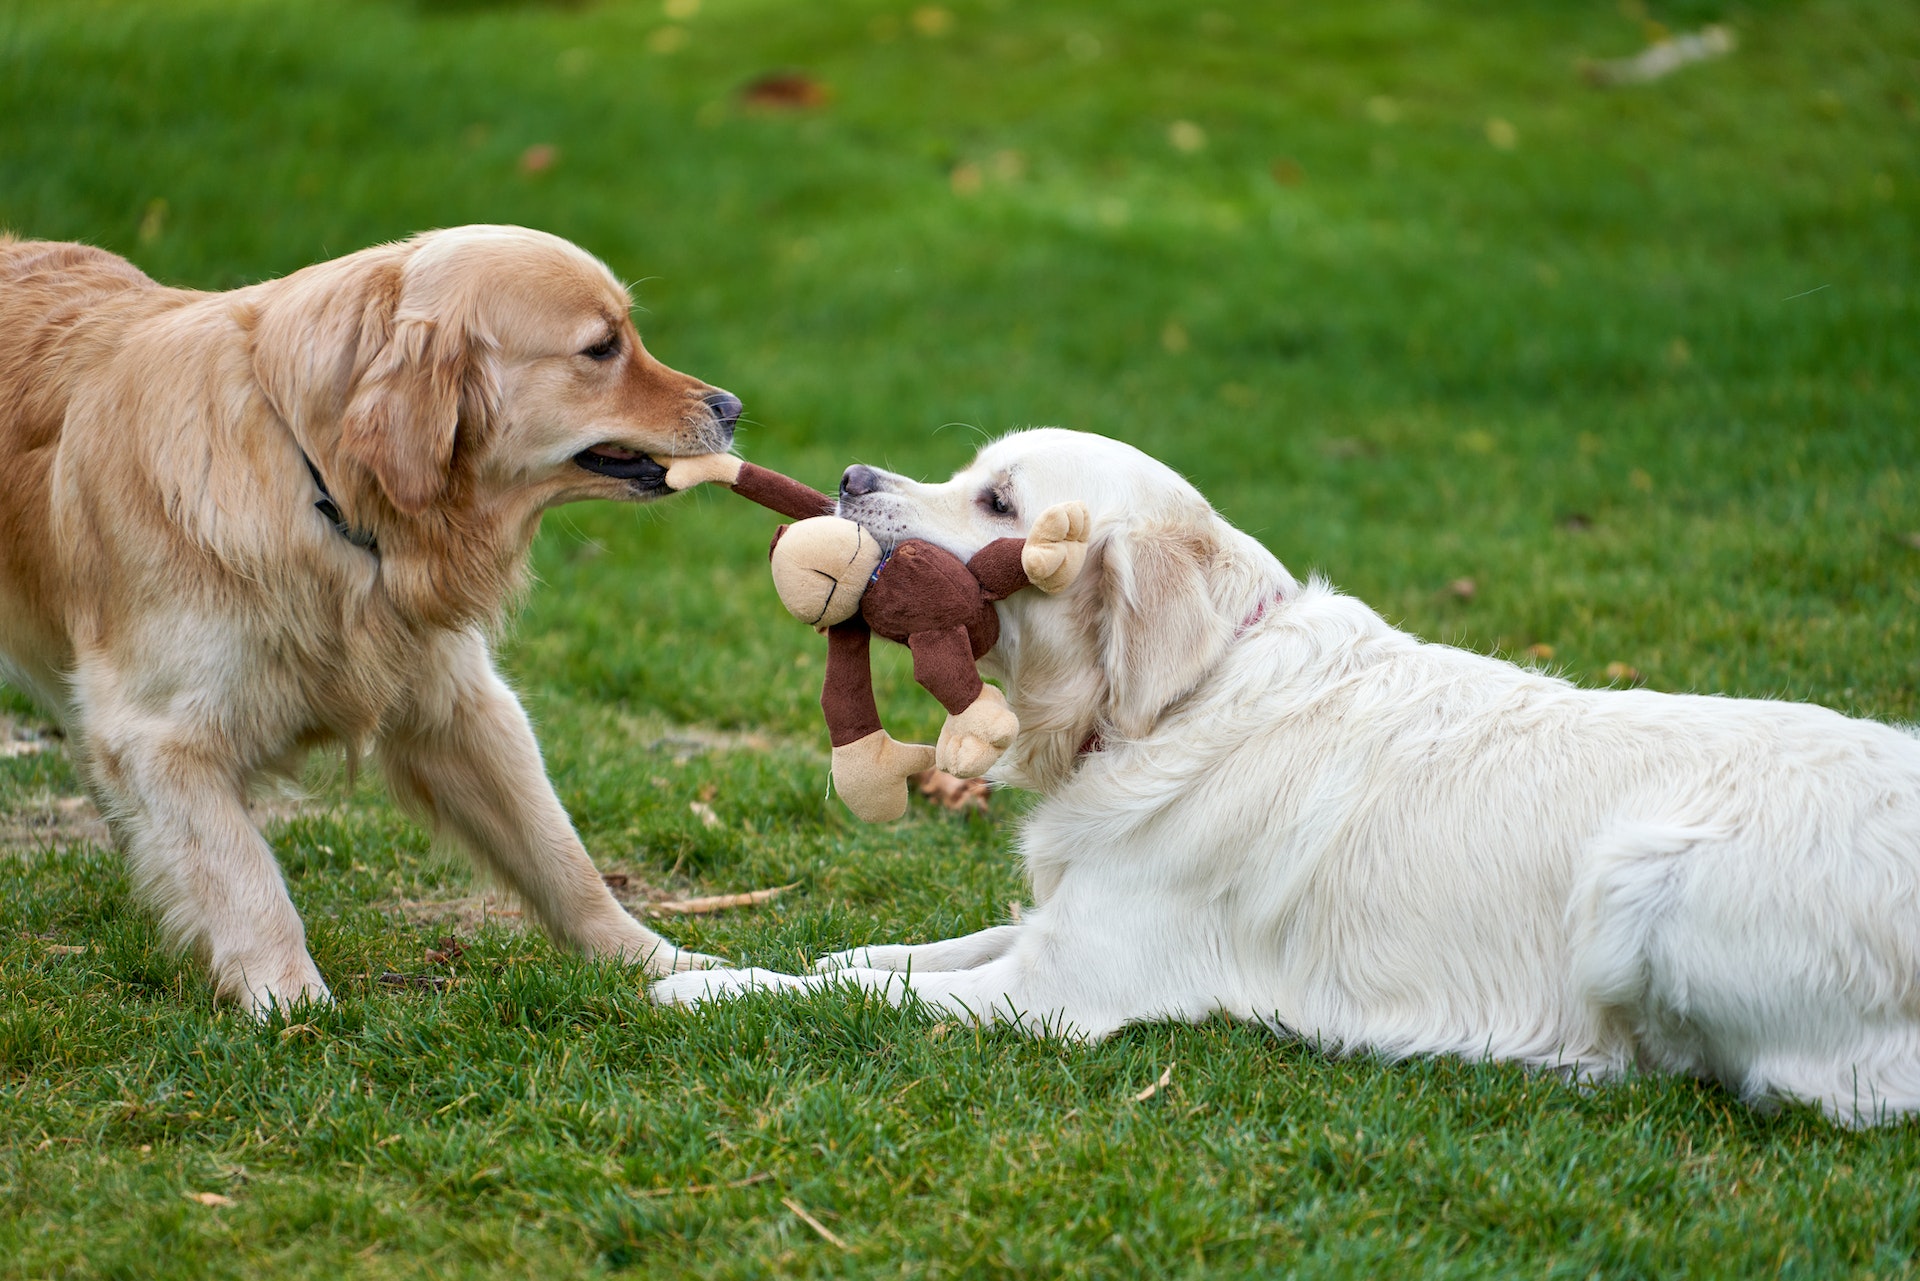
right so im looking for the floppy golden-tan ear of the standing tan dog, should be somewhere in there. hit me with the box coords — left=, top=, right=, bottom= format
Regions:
left=340, top=315, right=497, bottom=515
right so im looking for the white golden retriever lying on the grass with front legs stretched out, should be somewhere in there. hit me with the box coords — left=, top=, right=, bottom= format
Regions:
left=653, top=430, right=1920, bottom=1124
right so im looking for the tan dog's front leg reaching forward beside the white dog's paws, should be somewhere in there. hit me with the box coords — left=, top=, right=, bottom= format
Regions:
left=380, top=636, right=714, bottom=976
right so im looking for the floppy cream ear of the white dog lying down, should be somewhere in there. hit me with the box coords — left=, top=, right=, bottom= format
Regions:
left=1089, top=522, right=1233, bottom=737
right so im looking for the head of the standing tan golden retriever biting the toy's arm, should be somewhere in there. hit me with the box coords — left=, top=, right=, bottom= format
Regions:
left=250, top=227, right=739, bottom=526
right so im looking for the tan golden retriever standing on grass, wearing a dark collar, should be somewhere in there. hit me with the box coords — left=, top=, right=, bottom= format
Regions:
left=0, top=227, right=739, bottom=1014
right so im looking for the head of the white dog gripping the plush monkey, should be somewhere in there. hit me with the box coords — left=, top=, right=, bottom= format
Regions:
left=839, top=428, right=1294, bottom=791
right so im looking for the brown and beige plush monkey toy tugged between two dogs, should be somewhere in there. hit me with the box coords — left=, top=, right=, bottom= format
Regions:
left=666, top=453, right=1087, bottom=822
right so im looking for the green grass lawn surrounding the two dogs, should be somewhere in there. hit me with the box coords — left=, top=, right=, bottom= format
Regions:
left=0, top=0, right=1920, bottom=1277
